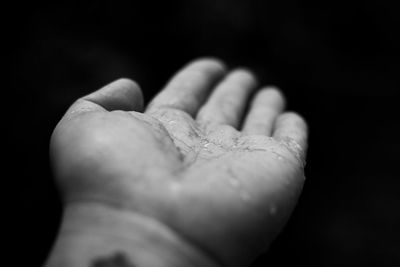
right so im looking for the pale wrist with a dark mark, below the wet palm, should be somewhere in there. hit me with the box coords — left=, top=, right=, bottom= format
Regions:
left=45, top=204, right=222, bottom=267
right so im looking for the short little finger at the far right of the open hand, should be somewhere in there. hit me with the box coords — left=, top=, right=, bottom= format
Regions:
left=273, top=112, right=308, bottom=159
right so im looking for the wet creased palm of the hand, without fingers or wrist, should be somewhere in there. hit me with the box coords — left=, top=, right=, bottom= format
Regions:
left=53, top=59, right=303, bottom=267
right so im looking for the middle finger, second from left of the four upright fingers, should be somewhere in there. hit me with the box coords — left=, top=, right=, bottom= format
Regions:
left=196, top=70, right=257, bottom=127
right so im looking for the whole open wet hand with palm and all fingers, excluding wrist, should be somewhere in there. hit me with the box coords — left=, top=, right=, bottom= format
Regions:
left=51, top=59, right=307, bottom=266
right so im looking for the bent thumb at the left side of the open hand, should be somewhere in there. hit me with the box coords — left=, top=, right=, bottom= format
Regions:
left=67, top=78, right=143, bottom=115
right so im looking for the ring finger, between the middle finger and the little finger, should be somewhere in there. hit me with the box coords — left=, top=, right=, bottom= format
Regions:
left=242, top=87, right=285, bottom=136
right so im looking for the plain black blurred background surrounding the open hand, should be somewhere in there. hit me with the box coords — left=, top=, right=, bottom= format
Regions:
left=8, top=0, right=400, bottom=267
